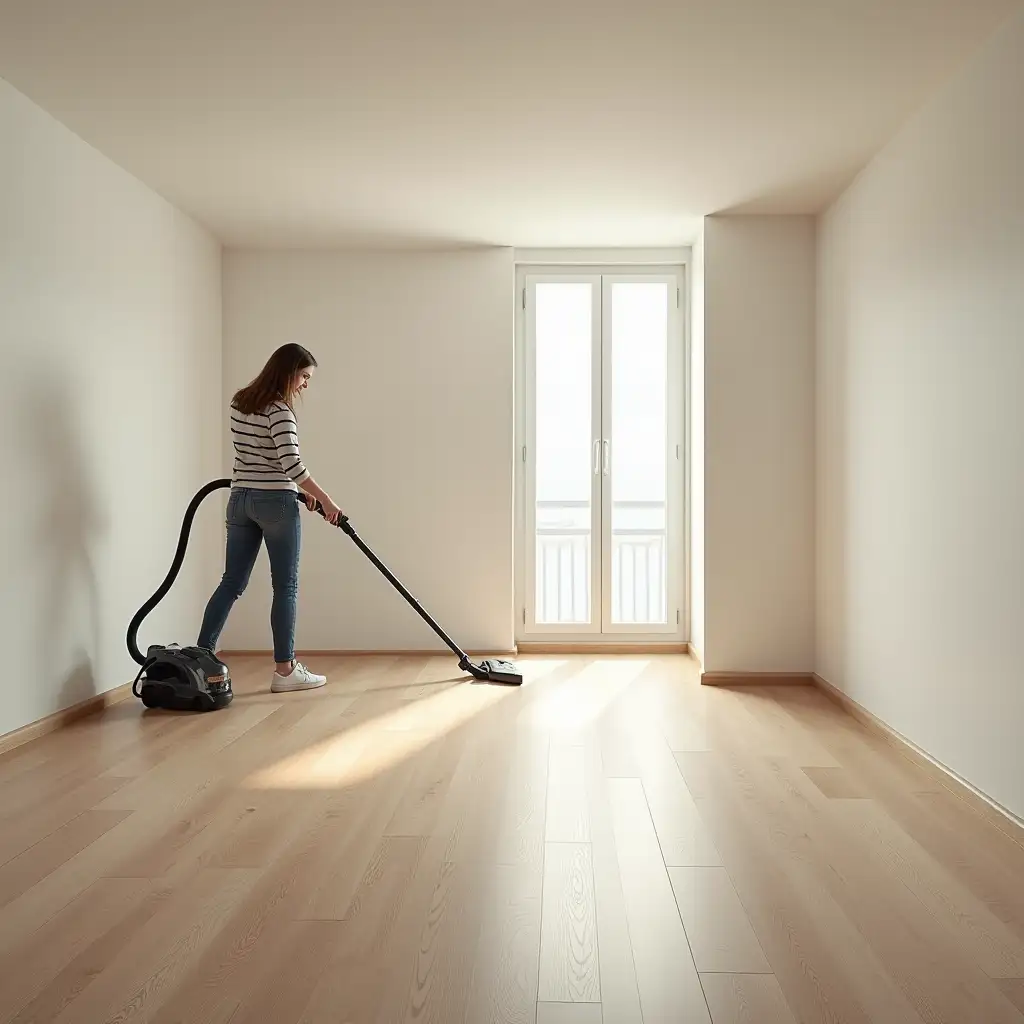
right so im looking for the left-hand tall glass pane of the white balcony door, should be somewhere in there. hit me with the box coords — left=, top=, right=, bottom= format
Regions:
left=535, top=283, right=593, bottom=624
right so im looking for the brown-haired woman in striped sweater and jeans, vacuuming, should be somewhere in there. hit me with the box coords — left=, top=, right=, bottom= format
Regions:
left=198, top=344, right=341, bottom=693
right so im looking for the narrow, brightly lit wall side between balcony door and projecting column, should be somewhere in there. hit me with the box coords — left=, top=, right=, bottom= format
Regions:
left=688, top=230, right=705, bottom=665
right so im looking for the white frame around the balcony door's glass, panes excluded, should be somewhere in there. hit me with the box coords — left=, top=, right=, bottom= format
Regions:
left=514, top=259, right=690, bottom=645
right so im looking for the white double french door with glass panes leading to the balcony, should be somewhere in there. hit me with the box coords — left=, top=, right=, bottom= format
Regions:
left=517, top=267, right=687, bottom=642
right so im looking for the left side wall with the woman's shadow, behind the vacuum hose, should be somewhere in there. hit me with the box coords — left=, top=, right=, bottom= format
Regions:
left=0, top=81, right=221, bottom=733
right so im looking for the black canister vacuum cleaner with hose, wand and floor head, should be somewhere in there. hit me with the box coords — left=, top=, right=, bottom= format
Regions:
left=127, top=479, right=522, bottom=711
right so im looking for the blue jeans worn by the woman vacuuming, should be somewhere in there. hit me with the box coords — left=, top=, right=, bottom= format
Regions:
left=198, top=487, right=302, bottom=665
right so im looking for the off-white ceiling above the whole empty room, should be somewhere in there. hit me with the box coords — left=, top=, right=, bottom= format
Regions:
left=0, top=0, right=1020, bottom=246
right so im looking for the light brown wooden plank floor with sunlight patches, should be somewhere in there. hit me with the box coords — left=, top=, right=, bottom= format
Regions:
left=0, top=655, right=1024, bottom=1024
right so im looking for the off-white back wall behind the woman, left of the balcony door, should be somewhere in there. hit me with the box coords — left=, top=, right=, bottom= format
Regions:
left=222, top=250, right=514, bottom=650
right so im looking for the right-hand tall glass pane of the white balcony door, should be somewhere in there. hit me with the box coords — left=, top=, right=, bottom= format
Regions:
left=611, top=282, right=669, bottom=625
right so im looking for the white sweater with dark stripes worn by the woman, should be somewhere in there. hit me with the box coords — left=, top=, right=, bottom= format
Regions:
left=231, top=401, right=309, bottom=490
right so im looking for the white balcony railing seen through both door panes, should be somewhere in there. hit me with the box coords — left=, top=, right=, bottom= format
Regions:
left=536, top=502, right=668, bottom=626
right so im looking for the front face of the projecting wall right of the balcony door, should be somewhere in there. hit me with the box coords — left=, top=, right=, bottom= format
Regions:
left=703, top=217, right=814, bottom=673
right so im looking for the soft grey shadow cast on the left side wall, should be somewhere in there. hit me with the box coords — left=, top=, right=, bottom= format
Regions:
left=23, top=372, right=109, bottom=711
